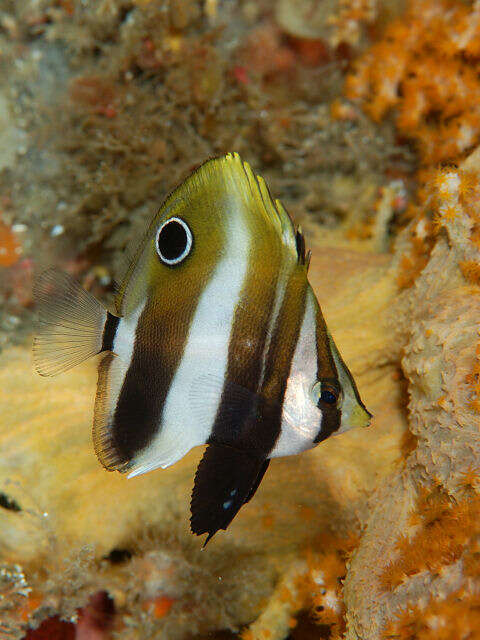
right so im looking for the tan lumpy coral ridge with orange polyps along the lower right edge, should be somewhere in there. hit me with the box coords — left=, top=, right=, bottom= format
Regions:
left=344, top=149, right=480, bottom=640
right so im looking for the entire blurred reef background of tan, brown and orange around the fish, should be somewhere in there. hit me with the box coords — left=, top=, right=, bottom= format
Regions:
left=0, top=0, right=480, bottom=640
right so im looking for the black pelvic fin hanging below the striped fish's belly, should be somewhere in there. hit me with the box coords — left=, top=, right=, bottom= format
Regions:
left=190, top=444, right=268, bottom=546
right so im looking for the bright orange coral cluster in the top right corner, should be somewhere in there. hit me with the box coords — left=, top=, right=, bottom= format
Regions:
left=345, top=0, right=480, bottom=165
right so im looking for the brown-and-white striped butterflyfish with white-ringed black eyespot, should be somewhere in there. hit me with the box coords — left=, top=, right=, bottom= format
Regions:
left=34, top=153, right=371, bottom=544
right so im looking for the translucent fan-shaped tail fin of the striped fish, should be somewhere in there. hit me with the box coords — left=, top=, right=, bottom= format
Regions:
left=33, top=268, right=107, bottom=376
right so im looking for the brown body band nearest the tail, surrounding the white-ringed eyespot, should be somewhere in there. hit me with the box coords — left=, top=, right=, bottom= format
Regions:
left=94, top=159, right=238, bottom=470
